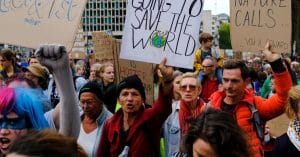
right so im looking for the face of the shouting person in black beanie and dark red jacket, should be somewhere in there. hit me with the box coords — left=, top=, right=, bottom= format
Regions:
left=118, top=88, right=143, bottom=114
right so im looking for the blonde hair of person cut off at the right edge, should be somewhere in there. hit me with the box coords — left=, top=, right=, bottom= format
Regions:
left=285, top=86, right=300, bottom=119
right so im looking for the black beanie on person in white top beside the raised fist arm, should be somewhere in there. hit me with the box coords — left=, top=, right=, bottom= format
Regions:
left=78, top=81, right=103, bottom=100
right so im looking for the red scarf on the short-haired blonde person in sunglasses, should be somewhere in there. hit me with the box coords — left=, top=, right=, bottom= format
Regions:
left=179, top=98, right=204, bottom=134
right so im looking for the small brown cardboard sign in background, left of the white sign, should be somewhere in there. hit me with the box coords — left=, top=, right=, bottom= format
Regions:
left=92, top=32, right=114, bottom=62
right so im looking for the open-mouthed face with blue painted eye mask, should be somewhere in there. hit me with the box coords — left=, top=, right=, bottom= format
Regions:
left=0, top=112, right=30, bottom=154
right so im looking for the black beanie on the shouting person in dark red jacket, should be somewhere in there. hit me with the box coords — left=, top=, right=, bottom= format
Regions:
left=117, top=75, right=146, bottom=101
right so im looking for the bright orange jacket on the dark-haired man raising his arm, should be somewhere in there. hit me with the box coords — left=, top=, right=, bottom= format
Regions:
left=206, top=71, right=292, bottom=157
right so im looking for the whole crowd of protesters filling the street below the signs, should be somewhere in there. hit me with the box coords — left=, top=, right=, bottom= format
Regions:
left=0, top=33, right=300, bottom=157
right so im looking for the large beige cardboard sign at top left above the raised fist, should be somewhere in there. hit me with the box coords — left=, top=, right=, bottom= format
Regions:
left=0, top=0, right=87, bottom=52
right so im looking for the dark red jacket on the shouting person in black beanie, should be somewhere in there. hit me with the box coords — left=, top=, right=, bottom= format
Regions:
left=97, top=91, right=172, bottom=157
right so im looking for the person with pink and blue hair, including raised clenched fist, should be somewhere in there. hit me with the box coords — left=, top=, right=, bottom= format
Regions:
left=0, top=44, right=80, bottom=156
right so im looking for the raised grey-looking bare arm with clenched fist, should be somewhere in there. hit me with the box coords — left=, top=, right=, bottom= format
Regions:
left=35, top=44, right=80, bottom=138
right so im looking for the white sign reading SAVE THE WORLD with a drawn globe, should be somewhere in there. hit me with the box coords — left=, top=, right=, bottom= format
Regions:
left=120, top=0, right=204, bottom=69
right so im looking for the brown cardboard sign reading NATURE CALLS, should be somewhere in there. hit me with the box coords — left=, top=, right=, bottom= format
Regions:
left=230, top=0, right=292, bottom=52
